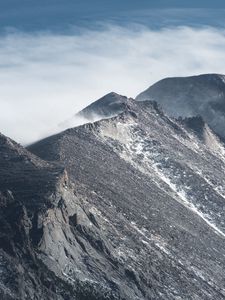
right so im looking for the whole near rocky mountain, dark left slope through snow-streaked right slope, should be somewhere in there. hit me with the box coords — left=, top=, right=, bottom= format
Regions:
left=0, top=78, right=225, bottom=300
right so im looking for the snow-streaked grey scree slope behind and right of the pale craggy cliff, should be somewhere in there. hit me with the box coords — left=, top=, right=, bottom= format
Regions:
left=26, top=99, right=225, bottom=299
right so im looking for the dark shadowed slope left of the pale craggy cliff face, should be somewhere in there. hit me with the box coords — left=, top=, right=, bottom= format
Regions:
left=0, top=135, right=72, bottom=299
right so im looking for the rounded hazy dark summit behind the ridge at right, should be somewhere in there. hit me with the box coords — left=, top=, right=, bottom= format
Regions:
left=136, top=74, right=225, bottom=139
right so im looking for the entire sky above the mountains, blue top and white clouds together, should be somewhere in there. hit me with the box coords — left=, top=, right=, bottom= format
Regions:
left=0, top=0, right=225, bottom=144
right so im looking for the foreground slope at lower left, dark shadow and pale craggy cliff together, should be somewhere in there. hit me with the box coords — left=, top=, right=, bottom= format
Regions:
left=0, top=135, right=139, bottom=300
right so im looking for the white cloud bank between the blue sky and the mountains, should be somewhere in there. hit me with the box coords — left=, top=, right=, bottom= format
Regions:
left=0, top=26, right=225, bottom=143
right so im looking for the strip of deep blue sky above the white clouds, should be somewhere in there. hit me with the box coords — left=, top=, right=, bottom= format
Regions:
left=0, top=0, right=225, bottom=32
